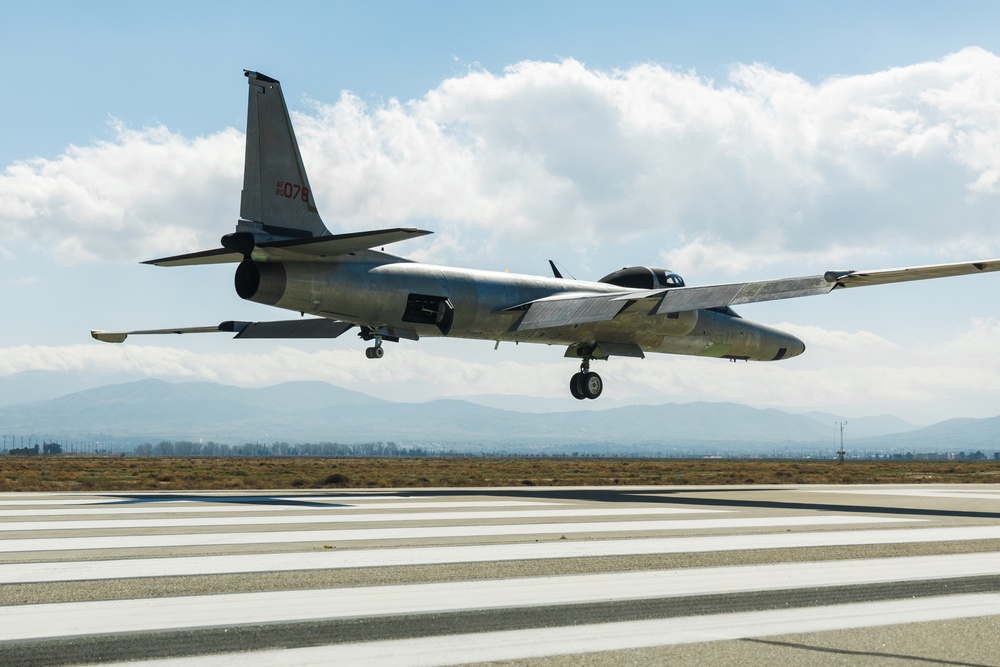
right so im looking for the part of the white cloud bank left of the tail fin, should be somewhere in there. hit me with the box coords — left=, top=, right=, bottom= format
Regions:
left=0, top=124, right=243, bottom=262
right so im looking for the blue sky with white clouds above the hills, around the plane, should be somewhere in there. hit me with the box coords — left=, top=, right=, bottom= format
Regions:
left=0, top=0, right=1000, bottom=428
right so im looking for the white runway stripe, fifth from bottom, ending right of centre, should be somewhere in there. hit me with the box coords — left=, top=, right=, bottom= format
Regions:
left=0, top=507, right=731, bottom=532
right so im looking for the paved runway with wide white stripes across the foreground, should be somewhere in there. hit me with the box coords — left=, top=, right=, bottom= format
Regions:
left=0, top=482, right=1000, bottom=666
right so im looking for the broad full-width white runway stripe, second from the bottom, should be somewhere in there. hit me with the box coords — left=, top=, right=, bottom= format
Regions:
left=0, top=553, right=1000, bottom=640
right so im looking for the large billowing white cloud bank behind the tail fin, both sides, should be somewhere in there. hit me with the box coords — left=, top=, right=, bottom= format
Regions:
left=0, top=48, right=1000, bottom=271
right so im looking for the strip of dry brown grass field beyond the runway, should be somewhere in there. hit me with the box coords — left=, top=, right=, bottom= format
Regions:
left=0, top=456, right=1000, bottom=492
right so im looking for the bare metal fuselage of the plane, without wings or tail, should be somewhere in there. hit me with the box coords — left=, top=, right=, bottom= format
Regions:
left=236, top=251, right=805, bottom=361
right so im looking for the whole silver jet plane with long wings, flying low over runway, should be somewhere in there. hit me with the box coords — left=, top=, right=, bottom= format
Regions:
left=91, top=71, right=1000, bottom=399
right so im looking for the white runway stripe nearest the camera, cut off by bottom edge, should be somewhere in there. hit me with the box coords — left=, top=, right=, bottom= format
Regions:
left=88, top=594, right=1000, bottom=667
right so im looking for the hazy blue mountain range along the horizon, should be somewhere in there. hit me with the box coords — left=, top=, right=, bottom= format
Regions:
left=0, top=379, right=976, bottom=454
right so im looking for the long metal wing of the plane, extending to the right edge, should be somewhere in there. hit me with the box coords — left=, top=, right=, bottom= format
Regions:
left=511, top=259, right=1000, bottom=330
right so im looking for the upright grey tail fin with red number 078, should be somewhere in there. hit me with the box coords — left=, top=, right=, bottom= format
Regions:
left=236, top=70, right=330, bottom=242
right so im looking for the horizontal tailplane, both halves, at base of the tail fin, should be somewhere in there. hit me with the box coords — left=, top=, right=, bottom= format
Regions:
left=143, top=227, right=432, bottom=266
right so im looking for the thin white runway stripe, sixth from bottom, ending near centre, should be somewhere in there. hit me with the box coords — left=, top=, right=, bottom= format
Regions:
left=0, top=499, right=559, bottom=518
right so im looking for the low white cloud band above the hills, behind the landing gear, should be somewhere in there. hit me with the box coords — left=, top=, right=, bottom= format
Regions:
left=0, top=320, right=1000, bottom=423
